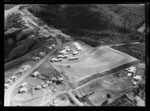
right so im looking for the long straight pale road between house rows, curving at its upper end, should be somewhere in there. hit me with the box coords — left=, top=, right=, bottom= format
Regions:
left=4, top=38, right=62, bottom=106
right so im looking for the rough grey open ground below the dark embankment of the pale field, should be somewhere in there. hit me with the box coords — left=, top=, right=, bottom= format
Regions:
left=75, top=74, right=132, bottom=106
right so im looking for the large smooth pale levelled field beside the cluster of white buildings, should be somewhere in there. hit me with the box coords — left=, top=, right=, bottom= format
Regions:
left=52, top=43, right=137, bottom=83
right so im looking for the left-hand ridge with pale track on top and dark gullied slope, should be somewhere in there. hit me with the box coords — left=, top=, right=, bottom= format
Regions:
left=4, top=5, right=71, bottom=62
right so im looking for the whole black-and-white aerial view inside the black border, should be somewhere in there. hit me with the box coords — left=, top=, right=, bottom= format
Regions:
left=3, top=4, right=146, bottom=107
